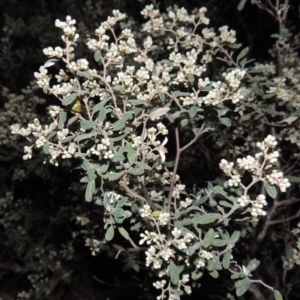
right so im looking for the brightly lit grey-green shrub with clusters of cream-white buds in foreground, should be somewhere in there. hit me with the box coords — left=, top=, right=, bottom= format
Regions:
left=3, top=1, right=300, bottom=300
